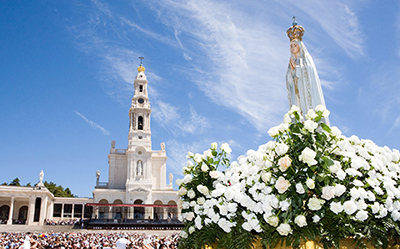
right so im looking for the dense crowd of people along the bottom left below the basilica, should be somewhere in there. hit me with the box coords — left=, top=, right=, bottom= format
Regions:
left=0, top=232, right=179, bottom=249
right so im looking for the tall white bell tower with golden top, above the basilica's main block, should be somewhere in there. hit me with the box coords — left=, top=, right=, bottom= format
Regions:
left=128, top=56, right=151, bottom=151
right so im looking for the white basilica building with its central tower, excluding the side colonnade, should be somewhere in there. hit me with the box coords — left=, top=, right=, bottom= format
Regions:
left=92, top=65, right=178, bottom=219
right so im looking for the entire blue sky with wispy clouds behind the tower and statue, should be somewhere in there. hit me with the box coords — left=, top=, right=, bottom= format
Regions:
left=0, top=0, right=400, bottom=197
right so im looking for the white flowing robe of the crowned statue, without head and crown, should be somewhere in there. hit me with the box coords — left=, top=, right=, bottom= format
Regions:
left=286, top=41, right=329, bottom=125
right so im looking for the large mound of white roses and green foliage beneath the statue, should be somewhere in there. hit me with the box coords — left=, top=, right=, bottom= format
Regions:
left=177, top=106, right=400, bottom=249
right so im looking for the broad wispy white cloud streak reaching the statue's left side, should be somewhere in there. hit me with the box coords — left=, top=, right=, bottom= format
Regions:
left=146, top=1, right=288, bottom=130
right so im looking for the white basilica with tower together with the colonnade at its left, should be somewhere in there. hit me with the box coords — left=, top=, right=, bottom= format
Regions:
left=0, top=64, right=179, bottom=225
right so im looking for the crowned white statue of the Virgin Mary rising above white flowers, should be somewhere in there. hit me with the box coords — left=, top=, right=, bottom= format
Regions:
left=286, top=18, right=329, bottom=125
